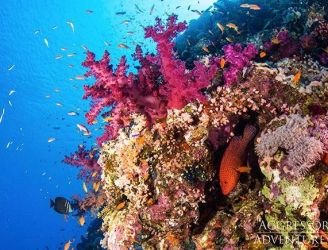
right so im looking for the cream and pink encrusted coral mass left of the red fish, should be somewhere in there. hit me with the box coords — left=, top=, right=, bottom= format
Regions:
left=99, top=81, right=268, bottom=249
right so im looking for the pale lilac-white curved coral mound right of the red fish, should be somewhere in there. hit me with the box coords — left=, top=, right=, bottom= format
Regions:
left=256, top=114, right=324, bottom=177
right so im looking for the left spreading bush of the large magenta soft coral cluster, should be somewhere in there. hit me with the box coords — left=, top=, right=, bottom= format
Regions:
left=83, top=47, right=165, bottom=144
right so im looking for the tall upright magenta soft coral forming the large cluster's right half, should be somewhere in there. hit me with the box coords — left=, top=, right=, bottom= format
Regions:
left=145, top=15, right=217, bottom=109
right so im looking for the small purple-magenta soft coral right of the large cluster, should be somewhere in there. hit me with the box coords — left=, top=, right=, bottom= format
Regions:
left=223, top=44, right=258, bottom=86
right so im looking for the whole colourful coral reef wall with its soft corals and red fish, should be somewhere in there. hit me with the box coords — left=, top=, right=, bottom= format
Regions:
left=64, top=1, right=328, bottom=250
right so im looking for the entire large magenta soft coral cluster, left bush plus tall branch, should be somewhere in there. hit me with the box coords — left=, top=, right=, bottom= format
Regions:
left=83, top=15, right=218, bottom=144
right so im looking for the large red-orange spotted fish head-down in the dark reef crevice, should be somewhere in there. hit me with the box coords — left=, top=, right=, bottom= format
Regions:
left=219, top=125, right=256, bottom=195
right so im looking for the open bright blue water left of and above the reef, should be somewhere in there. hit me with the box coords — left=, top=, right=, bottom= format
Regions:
left=0, top=0, right=213, bottom=250
